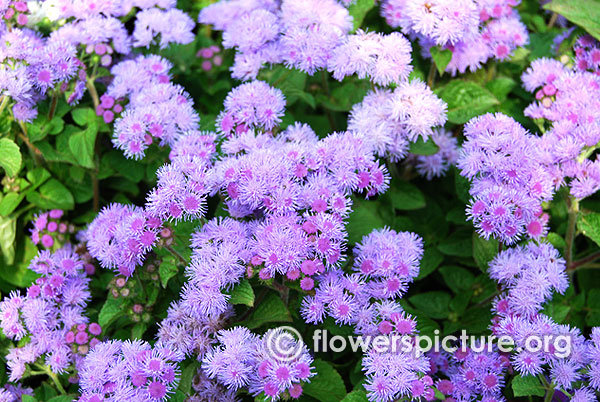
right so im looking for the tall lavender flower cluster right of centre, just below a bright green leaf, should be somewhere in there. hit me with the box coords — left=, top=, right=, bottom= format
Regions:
left=458, top=114, right=553, bottom=244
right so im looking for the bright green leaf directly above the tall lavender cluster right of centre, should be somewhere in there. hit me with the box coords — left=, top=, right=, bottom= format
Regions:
left=435, top=80, right=500, bottom=124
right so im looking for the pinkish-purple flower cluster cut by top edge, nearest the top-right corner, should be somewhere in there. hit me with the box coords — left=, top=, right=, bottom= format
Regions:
left=381, top=0, right=529, bottom=75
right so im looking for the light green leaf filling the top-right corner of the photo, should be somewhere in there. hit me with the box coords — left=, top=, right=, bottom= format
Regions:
left=544, top=0, right=600, bottom=40
